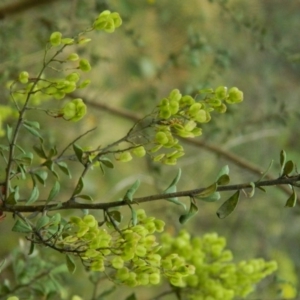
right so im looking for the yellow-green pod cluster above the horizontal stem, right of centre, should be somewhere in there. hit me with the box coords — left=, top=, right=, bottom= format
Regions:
left=151, top=86, right=243, bottom=165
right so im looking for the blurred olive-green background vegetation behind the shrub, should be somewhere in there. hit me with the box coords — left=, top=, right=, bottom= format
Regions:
left=0, top=0, right=300, bottom=299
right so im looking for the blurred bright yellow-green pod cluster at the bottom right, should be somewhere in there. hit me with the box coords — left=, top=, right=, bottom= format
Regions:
left=160, top=230, right=277, bottom=300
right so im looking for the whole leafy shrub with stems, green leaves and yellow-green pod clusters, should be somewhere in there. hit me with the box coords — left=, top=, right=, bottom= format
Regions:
left=0, top=1, right=299, bottom=300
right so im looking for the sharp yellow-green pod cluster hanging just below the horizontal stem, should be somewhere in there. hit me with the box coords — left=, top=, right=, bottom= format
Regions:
left=57, top=209, right=195, bottom=287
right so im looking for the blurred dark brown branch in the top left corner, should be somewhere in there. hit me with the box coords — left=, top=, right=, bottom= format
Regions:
left=0, top=0, right=61, bottom=19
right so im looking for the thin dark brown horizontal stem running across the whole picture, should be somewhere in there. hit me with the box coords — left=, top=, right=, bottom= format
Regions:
left=1, top=175, right=300, bottom=213
